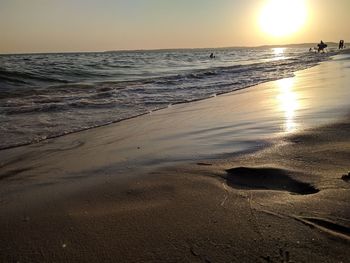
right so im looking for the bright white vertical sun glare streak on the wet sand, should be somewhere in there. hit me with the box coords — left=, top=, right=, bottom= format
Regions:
left=277, top=78, right=299, bottom=132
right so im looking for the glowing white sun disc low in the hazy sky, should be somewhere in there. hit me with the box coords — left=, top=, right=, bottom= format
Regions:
left=259, top=0, right=307, bottom=37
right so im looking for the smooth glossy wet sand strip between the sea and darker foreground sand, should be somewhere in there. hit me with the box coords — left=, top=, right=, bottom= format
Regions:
left=0, top=55, right=350, bottom=179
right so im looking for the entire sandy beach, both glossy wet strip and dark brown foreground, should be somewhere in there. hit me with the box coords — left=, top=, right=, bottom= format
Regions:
left=0, top=53, right=350, bottom=262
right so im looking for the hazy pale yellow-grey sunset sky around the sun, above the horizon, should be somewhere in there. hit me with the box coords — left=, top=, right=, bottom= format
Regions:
left=0, top=0, right=350, bottom=53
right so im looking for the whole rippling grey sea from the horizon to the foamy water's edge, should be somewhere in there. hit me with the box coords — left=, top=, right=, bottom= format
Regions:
left=0, top=46, right=332, bottom=149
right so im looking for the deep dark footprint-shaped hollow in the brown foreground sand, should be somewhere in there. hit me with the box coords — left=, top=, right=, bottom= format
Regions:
left=226, top=167, right=319, bottom=195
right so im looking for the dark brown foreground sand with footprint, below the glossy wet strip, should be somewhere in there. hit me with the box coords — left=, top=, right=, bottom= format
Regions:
left=0, top=121, right=350, bottom=262
